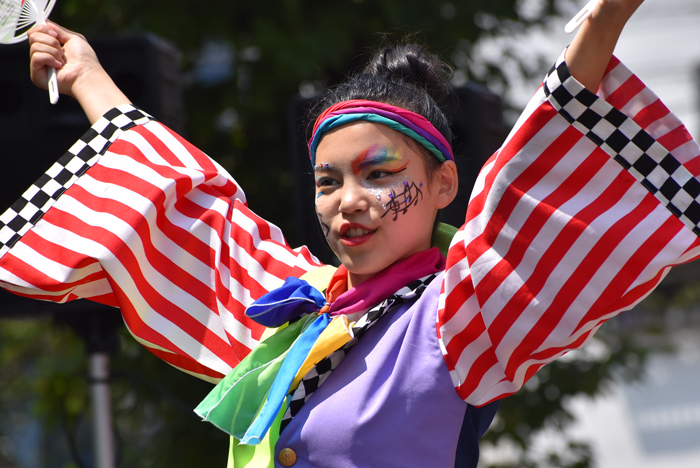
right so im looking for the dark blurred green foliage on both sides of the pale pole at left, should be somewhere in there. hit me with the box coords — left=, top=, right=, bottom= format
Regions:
left=0, top=317, right=228, bottom=468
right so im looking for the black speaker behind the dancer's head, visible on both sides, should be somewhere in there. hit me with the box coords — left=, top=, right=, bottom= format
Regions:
left=288, top=83, right=506, bottom=263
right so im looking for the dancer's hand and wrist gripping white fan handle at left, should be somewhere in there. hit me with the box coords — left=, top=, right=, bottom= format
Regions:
left=28, top=22, right=130, bottom=124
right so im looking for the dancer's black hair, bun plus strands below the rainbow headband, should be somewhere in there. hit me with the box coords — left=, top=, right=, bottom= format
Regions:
left=310, top=43, right=452, bottom=179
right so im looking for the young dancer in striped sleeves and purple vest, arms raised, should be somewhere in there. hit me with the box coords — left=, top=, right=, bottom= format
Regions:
left=0, top=0, right=700, bottom=467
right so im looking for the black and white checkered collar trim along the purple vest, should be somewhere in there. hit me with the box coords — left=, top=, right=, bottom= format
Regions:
left=280, top=274, right=437, bottom=433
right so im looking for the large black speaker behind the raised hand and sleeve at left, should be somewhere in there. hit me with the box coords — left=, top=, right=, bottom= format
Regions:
left=0, top=35, right=185, bottom=320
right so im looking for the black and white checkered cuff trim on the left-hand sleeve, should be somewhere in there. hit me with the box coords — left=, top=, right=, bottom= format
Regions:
left=0, top=105, right=153, bottom=257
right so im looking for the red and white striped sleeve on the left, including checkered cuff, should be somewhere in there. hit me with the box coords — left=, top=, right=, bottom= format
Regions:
left=0, top=106, right=320, bottom=381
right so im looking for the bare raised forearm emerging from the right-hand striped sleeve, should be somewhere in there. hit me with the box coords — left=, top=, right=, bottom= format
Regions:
left=566, top=0, right=644, bottom=93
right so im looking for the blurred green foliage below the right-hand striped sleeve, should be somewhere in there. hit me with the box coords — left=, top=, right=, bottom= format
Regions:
left=482, top=330, right=652, bottom=468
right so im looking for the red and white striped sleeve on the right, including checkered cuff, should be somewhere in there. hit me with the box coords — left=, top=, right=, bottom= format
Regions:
left=437, top=51, right=700, bottom=405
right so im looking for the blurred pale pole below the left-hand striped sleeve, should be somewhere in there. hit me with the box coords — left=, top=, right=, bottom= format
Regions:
left=88, top=353, right=115, bottom=468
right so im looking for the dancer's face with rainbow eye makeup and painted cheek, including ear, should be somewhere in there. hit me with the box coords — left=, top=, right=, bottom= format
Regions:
left=314, top=122, right=456, bottom=286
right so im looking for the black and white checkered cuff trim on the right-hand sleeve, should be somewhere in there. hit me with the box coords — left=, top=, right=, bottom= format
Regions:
left=543, top=55, right=700, bottom=236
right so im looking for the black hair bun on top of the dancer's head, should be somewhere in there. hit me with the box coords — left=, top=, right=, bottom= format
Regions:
left=362, top=43, right=453, bottom=103
